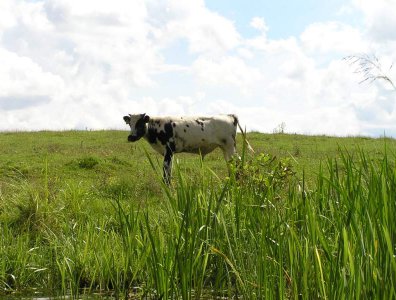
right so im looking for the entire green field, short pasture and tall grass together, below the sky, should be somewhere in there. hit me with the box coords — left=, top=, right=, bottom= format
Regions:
left=0, top=131, right=396, bottom=299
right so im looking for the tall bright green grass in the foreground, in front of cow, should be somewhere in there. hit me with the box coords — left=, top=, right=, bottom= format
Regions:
left=0, top=146, right=396, bottom=299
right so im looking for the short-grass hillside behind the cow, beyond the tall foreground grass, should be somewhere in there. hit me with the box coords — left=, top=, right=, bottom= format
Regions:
left=0, top=131, right=396, bottom=189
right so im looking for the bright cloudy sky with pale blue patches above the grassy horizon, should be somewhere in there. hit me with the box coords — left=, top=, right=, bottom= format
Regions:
left=0, top=0, right=396, bottom=137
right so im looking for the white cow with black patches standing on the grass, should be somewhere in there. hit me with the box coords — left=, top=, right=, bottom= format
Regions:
left=124, top=113, right=251, bottom=185
